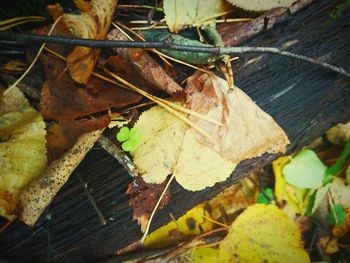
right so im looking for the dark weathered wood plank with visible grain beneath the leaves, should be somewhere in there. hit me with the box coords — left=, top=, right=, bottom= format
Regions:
left=0, top=1, right=350, bottom=262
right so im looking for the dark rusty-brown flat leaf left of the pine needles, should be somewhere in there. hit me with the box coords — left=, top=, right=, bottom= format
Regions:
left=40, top=55, right=142, bottom=122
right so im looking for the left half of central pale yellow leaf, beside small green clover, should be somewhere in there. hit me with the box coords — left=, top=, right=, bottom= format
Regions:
left=131, top=106, right=188, bottom=184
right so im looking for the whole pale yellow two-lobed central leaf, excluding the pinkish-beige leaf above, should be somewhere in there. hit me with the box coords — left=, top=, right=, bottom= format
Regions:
left=131, top=103, right=236, bottom=191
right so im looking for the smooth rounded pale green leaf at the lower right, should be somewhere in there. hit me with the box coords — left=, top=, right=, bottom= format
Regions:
left=283, top=149, right=327, bottom=189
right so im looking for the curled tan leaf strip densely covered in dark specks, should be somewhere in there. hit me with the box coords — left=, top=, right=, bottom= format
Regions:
left=16, top=130, right=103, bottom=225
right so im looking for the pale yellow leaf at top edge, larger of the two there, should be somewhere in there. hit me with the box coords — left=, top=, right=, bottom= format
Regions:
left=163, top=0, right=232, bottom=33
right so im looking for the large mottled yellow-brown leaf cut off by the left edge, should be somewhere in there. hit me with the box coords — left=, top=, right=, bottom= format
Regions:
left=0, top=87, right=47, bottom=219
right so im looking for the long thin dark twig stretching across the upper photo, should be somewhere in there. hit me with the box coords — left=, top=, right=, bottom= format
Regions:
left=0, top=32, right=350, bottom=77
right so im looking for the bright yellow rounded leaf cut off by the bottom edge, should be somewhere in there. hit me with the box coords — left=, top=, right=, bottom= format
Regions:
left=220, top=204, right=310, bottom=263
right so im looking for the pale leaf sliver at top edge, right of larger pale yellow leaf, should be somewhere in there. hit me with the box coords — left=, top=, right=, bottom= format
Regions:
left=227, top=0, right=295, bottom=11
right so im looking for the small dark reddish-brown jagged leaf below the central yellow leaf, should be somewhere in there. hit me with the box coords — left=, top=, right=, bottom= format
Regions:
left=126, top=176, right=170, bottom=231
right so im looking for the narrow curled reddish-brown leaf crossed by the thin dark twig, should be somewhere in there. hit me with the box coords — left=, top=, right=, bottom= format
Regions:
left=106, top=29, right=184, bottom=95
